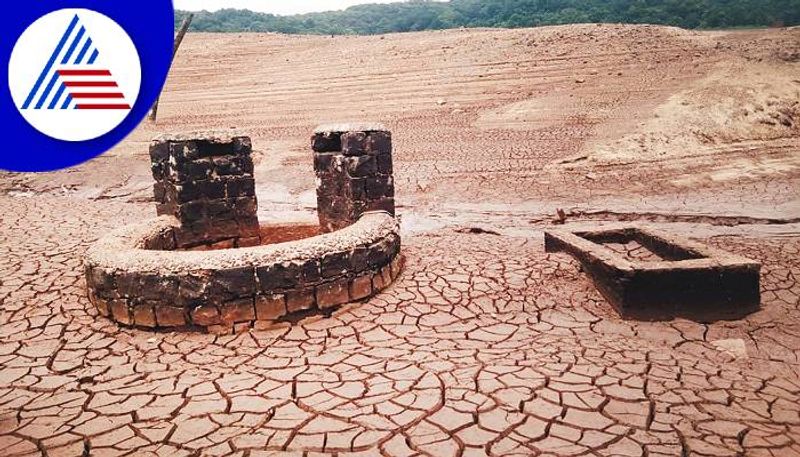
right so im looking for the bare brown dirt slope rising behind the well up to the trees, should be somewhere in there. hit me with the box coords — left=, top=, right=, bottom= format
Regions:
left=3, top=25, right=800, bottom=221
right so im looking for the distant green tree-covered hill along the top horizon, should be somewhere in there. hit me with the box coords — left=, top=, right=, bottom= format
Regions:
left=175, top=0, right=800, bottom=35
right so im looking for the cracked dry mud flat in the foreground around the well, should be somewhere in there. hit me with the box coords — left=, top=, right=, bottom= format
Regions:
left=0, top=197, right=800, bottom=456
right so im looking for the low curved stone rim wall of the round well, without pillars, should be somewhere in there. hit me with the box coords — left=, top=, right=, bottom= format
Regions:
left=85, top=212, right=402, bottom=332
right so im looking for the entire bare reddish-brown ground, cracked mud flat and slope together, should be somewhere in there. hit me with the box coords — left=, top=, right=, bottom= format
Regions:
left=0, top=25, right=800, bottom=456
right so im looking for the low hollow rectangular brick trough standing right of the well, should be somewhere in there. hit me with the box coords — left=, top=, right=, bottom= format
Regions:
left=544, top=227, right=761, bottom=321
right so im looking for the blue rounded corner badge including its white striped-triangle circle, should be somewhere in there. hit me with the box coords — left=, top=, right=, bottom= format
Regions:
left=0, top=0, right=174, bottom=171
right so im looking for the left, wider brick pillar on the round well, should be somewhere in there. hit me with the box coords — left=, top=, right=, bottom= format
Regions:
left=150, top=132, right=259, bottom=249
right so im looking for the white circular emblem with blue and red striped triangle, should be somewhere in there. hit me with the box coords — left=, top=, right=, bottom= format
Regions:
left=8, top=9, right=141, bottom=141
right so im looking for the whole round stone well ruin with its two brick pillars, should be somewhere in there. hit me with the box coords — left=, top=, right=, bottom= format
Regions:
left=85, top=125, right=402, bottom=333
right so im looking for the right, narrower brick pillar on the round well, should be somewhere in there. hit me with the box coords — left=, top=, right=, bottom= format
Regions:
left=311, top=124, right=394, bottom=232
